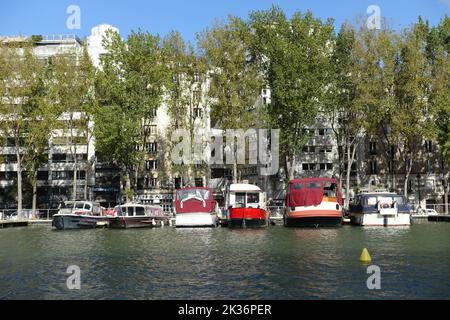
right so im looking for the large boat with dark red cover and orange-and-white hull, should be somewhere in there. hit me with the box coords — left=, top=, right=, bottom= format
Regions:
left=285, top=178, right=343, bottom=228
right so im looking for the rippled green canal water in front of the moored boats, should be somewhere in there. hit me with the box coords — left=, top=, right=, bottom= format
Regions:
left=0, top=223, right=450, bottom=299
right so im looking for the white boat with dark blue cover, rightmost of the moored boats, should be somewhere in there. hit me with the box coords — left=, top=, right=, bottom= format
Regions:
left=348, top=192, right=411, bottom=227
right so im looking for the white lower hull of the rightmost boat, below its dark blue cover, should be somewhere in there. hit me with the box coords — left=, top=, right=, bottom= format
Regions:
left=350, top=213, right=411, bottom=227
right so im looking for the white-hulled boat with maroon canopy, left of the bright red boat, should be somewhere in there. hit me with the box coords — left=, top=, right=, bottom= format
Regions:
left=175, top=187, right=218, bottom=227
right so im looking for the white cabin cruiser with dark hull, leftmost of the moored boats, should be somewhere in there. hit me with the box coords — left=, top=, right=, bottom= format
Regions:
left=52, top=201, right=107, bottom=230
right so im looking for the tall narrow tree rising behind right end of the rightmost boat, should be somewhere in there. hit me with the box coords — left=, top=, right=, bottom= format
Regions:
left=391, top=18, right=433, bottom=196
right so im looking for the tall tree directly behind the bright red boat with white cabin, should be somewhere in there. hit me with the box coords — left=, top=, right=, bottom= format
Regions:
left=197, top=16, right=262, bottom=182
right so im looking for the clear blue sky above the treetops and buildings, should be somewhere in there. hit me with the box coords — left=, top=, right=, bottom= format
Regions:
left=0, top=0, right=450, bottom=41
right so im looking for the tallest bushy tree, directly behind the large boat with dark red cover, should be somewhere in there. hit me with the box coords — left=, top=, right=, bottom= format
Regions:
left=249, top=7, right=334, bottom=179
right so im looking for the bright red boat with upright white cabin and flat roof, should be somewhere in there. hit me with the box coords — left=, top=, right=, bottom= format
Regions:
left=226, top=183, right=269, bottom=228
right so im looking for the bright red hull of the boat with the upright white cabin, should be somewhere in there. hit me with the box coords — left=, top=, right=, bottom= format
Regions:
left=228, top=208, right=269, bottom=228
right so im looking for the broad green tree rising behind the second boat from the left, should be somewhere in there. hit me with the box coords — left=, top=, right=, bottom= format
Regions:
left=95, top=31, right=168, bottom=200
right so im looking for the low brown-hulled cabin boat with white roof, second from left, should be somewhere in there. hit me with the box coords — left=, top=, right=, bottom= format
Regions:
left=108, top=203, right=170, bottom=229
